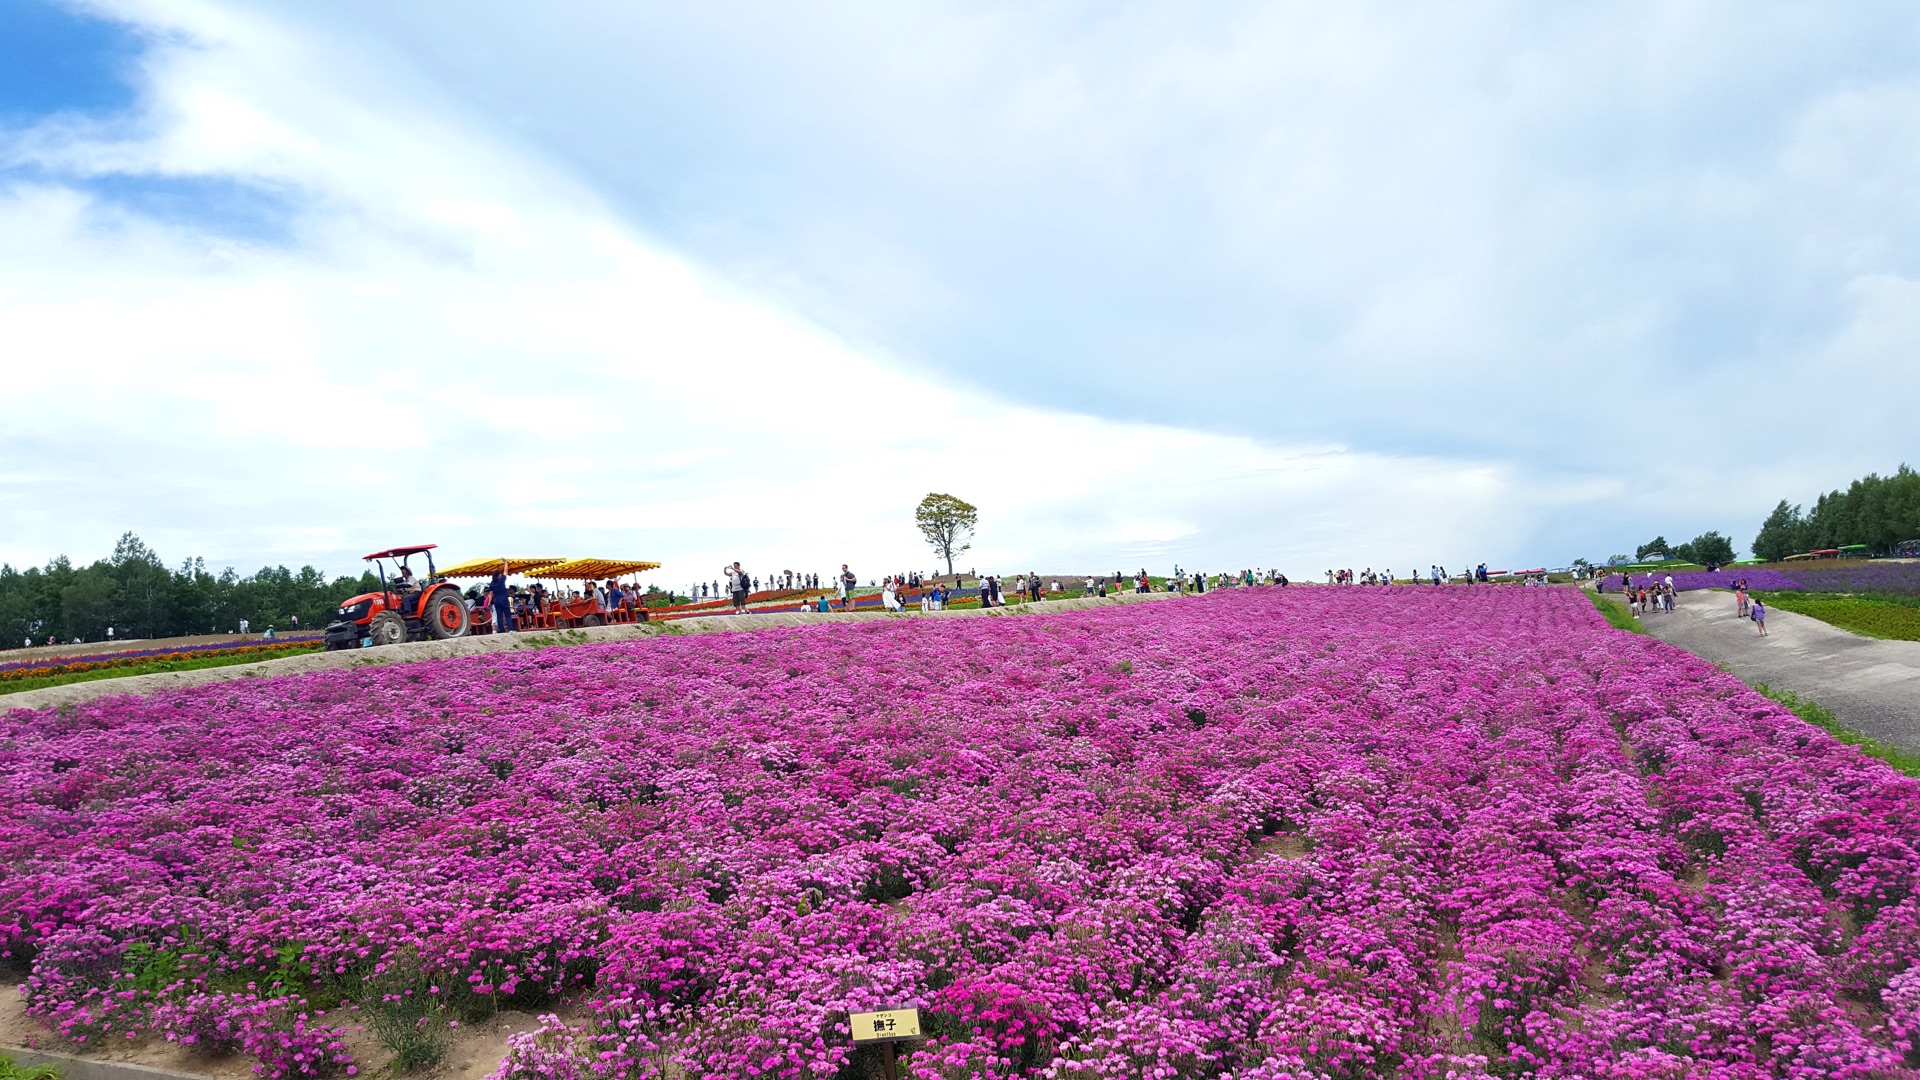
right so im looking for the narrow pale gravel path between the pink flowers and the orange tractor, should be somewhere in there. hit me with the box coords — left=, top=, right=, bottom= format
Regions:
left=0, top=592, right=1179, bottom=709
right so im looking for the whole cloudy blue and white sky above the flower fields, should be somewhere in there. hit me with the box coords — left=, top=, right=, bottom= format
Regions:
left=0, top=0, right=1920, bottom=573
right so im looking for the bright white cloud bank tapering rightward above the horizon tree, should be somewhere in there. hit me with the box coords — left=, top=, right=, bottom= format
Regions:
left=0, top=0, right=1589, bottom=582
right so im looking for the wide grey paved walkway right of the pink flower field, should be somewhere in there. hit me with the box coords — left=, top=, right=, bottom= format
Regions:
left=1611, top=590, right=1920, bottom=751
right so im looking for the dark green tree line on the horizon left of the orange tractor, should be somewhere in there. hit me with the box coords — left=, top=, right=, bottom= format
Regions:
left=0, top=532, right=380, bottom=648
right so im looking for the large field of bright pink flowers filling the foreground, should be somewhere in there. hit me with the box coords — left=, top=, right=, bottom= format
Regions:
left=0, top=588, right=1920, bottom=1080
